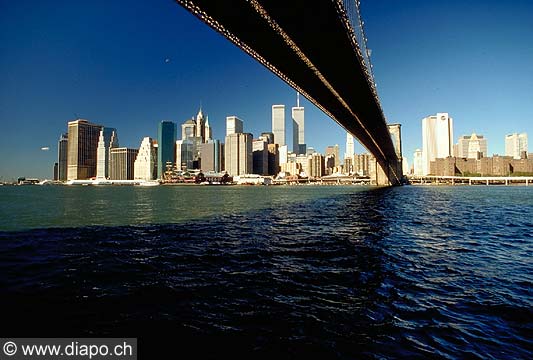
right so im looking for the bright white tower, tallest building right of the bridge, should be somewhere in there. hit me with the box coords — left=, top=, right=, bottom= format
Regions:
left=422, top=113, right=453, bottom=175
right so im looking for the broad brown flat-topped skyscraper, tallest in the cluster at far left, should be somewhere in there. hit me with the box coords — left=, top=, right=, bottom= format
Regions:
left=67, top=119, right=102, bottom=180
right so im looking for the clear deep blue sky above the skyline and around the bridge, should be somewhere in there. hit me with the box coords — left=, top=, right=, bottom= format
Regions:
left=0, top=0, right=533, bottom=180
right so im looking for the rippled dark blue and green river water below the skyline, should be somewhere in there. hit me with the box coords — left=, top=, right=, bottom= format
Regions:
left=0, top=186, right=533, bottom=359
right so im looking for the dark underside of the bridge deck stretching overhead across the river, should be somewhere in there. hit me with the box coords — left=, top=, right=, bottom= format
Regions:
left=176, top=0, right=401, bottom=184
